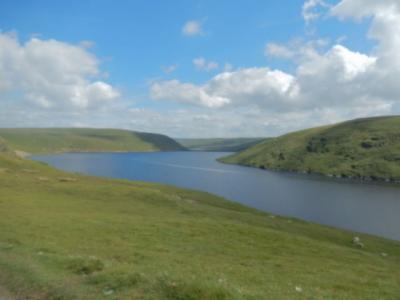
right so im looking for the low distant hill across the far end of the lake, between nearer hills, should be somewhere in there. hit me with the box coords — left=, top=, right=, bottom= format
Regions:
left=177, top=138, right=265, bottom=152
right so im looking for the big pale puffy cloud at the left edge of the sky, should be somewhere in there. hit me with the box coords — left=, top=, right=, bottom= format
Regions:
left=0, top=33, right=119, bottom=109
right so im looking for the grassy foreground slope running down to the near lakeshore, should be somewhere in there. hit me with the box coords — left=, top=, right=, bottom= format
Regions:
left=0, top=145, right=400, bottom=300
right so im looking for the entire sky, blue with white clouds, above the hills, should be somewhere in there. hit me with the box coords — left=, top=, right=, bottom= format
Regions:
left=0, top=0, right=400, bottom=138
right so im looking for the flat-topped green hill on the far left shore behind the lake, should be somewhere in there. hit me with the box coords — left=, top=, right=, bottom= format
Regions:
left=0, top=128, right=183, bottom=153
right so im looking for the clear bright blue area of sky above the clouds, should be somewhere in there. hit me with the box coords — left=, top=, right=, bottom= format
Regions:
left=0, top=0, right=370, bottom=83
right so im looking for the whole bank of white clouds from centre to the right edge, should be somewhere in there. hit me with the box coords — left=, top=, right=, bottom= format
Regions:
left=150, top=0, right=400, bottom=126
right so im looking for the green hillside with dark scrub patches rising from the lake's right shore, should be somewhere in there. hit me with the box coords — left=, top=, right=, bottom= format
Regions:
left=222, top=116, right=400, bottom=181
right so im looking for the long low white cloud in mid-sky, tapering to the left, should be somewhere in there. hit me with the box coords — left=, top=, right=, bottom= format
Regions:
left=150, top=68, right=298, bottom=109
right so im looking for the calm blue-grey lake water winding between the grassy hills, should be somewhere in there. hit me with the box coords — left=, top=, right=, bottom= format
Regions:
left=33, top=152, right=400, bottom=240
